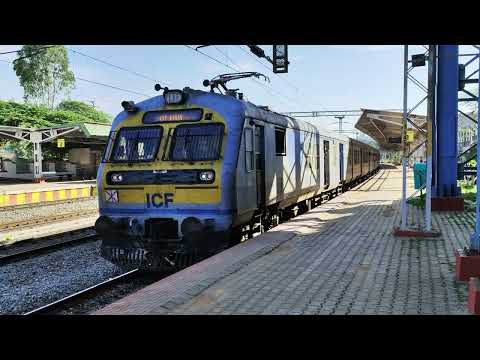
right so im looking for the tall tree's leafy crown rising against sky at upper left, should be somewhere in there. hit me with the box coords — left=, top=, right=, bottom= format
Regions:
left=13, top=45, right=75, bottom=109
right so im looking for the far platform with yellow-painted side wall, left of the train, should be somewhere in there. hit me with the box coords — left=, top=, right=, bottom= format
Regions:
left=0, top=180, right=96, bottom=208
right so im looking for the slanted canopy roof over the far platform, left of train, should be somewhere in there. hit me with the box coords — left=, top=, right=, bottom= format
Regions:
left=0, top=123, right=110, bottom=145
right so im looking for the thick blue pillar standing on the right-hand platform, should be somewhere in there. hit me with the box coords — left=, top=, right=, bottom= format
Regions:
left=432, top=45, right=459, bottom=197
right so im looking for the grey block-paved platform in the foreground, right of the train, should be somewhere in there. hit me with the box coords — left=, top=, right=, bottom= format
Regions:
left=94, top=168, right=475, bottom=315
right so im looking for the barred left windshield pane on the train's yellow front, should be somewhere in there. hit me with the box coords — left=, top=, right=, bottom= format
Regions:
left=111, top=127, right=163, bottom=162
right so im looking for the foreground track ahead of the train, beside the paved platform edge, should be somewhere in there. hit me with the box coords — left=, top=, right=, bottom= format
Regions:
left=23, top=269, right=152, bottom=315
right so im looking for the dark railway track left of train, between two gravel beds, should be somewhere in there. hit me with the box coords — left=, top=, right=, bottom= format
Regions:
left=0, top=227, right=99, bottom=265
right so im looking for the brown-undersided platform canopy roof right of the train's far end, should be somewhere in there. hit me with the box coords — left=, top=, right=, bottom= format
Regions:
left=355, top=109, right=427, bottom=151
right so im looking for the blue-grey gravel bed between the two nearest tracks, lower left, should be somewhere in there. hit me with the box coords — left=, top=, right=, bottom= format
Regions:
left=0, top=241, right=123, bottom=315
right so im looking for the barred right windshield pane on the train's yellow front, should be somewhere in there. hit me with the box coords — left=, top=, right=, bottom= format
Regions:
left=170, top=124, right=224, bottom=161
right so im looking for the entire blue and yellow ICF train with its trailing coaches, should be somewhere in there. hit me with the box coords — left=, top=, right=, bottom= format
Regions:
left=95, top=84, right=379, bottom=270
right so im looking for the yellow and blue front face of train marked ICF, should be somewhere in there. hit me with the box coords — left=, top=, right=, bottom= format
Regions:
left=95, top=91, right=242, bottom=269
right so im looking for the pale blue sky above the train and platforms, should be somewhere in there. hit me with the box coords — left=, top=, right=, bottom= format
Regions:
left=0, top=45, right=446, bottom=134
